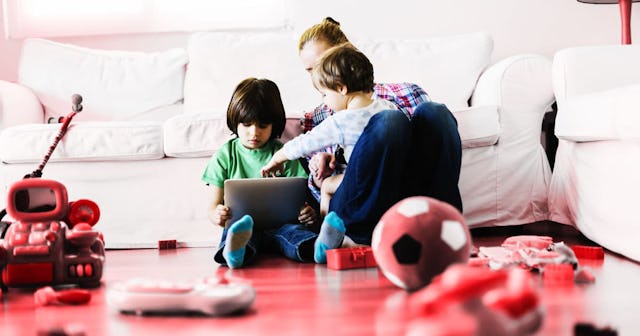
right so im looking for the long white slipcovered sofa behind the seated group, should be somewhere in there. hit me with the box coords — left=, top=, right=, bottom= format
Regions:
left=0, top=31, right=553, bottom=248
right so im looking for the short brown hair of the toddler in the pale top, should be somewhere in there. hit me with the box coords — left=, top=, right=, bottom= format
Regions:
left=312, top=43, right=375, bottom=92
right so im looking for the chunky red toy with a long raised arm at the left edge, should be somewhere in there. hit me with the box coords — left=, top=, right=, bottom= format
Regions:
left=0, top=95, right=105, bottom=290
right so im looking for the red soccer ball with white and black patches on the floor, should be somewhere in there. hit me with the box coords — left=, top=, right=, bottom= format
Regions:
left=371, top=196, right=471, bottom=291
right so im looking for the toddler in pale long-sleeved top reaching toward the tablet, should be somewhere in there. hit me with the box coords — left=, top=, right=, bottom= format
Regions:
left=261, top=43, right=396, bottom=263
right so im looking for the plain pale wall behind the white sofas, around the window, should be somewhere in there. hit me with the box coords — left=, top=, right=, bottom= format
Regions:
left=0, top=0, right=640, bottom=81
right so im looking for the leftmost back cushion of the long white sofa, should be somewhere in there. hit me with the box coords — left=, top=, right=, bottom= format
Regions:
left=18, top=39, right=188, bottom=121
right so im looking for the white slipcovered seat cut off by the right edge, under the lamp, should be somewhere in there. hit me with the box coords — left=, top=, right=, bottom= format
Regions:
left=549, top=45, right=640, bottom=261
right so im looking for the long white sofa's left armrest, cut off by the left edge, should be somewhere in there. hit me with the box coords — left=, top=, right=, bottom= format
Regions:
left=0, top=80, right=44, bottom=129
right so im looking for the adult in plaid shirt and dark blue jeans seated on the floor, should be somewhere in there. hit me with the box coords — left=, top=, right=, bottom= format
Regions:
left=298, top=17, right=462, bottom=244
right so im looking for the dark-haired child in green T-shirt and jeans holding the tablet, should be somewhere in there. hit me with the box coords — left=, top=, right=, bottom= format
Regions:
left=202, top=78, right=317, bottom=268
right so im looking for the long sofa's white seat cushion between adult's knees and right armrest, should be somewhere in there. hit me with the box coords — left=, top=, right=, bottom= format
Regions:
left=453, top=105, right=500, bottom=148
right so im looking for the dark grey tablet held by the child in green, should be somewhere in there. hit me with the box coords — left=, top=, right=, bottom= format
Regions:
left=224, top=177, right=308, bottom=228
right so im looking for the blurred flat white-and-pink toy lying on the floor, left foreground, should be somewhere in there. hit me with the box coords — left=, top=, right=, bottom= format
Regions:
left=107, top=279, right=256, bottom=316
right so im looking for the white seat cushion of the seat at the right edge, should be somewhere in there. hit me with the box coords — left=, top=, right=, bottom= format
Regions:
left=555, top=84, right=640, bottom=142
